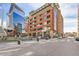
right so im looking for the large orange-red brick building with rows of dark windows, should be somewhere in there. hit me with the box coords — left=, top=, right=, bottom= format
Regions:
left=25, top=3, right=63, bottom=37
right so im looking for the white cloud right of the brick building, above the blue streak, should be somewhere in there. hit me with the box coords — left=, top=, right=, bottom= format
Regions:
left=60, top=3, right=77, bottom=18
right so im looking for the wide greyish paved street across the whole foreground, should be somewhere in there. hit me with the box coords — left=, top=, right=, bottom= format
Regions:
left=0, top=38, right=79, bottom=56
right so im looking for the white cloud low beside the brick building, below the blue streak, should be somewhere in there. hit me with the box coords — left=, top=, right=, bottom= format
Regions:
left=64, top=18, right=77, bottom=32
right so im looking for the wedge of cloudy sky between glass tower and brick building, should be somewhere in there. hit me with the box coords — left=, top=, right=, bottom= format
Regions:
left=17, top=3, right=44, bottom=16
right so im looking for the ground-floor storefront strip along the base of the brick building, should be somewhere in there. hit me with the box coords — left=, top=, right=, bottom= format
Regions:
left=27, top=31, right=63, bottom=38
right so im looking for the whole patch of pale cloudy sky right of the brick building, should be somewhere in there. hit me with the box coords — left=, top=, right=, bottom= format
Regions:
left=60, top=3, right=77, bottom=32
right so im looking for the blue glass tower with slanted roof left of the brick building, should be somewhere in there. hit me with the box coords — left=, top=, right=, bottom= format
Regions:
left=8, top=3, right=24, bottom=30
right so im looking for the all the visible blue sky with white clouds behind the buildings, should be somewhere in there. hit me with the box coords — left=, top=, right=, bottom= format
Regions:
left=0, top=3, right=78, bottom=32
